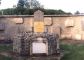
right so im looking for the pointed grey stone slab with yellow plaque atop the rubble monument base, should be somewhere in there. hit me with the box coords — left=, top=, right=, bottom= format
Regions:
left=34, top=10, right=44, bottom=32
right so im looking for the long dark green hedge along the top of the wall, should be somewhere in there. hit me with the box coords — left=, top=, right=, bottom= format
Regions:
left=0, top=7, right=71, bottom=15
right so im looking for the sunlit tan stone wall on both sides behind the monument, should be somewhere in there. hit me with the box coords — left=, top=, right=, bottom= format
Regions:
left=0, top=15, right=84, bottom=40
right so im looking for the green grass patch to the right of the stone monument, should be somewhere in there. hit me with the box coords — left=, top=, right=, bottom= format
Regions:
left=60, top=44, right=84, bottom=60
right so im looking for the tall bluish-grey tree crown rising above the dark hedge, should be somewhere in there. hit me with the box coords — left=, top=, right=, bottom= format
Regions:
left=17, top=0, right=41, bottom=9
